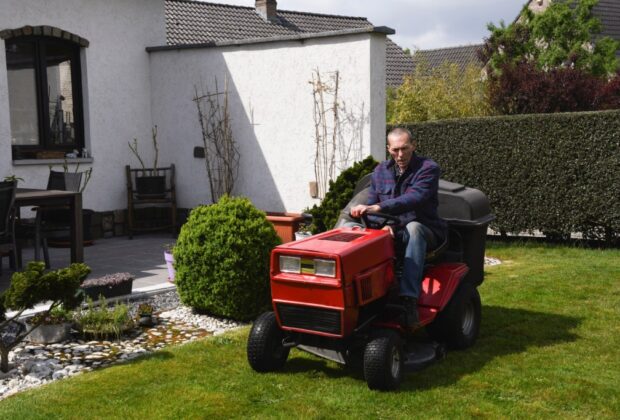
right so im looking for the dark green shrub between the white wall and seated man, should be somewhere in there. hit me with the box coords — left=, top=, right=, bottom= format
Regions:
left=307, top=156, right=378, bottom=233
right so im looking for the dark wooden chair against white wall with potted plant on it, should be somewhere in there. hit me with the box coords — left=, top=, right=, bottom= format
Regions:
left=125, top=165, right=177, bottom=239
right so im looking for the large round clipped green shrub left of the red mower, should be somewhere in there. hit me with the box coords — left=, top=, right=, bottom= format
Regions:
left=173, top=196, right=280, bottom=321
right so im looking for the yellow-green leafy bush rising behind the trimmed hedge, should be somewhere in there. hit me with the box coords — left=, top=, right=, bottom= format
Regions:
left=387, top=57, right=491, bottom=124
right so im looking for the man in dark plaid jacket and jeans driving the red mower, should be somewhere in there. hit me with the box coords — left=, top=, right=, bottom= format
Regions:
left=351, top=128, right=447, bottom=329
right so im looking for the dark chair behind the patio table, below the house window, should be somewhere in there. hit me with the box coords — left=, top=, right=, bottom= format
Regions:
left=17, top=170, right=83, bottom=268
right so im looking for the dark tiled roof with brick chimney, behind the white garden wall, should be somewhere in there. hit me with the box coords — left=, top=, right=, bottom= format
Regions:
left=165, top=0, right=413, bottom=86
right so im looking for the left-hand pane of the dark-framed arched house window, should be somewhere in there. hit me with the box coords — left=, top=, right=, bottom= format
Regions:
left=6, top=42, right=40, bottom=146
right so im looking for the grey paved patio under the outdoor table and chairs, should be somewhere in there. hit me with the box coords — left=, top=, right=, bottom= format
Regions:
left=0, top=232, right=174, bottom=293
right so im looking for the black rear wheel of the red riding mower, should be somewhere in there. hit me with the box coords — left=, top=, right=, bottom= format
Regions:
left=426, top=283, right=482, bottom=350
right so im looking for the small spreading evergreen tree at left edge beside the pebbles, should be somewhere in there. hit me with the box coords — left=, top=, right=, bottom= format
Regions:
left=0, top=262, right=90, bottom=372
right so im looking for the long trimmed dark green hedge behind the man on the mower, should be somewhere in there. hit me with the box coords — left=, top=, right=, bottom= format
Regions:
left=400, top=110, right=620, bottom=241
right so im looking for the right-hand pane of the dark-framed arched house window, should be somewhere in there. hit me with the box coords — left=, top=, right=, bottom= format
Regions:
left=45, top=44, right=75, bottom=146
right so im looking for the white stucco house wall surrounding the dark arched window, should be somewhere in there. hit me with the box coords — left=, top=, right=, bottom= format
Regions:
left=0, top=0, right=165, bottom=211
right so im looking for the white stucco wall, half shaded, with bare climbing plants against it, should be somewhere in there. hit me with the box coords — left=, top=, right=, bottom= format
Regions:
left=151, top=33, right=385, bottom=211
